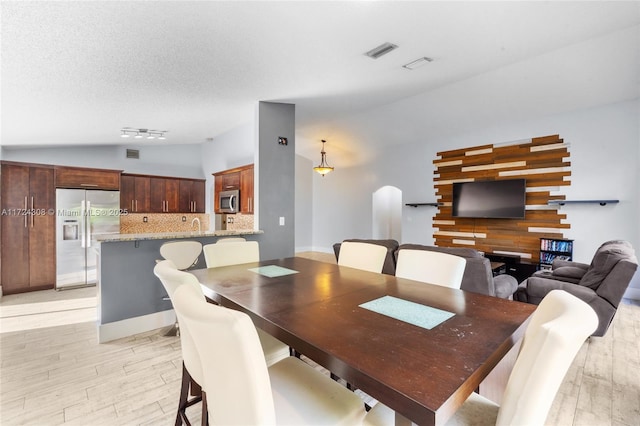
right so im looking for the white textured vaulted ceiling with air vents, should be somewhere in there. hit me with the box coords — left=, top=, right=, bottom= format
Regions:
left=1, top=1, right=640, bottom=152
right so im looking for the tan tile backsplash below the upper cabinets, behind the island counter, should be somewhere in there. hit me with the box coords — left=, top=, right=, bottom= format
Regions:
left=120, top=213, right=209, bottom=234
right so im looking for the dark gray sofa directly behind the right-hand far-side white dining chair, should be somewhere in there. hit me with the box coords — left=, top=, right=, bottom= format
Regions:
left=395, top=244, right=518, bottom=299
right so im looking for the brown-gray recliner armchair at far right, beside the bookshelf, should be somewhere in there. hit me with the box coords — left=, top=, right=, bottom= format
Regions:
left=514, top=240, right=638, bottom=336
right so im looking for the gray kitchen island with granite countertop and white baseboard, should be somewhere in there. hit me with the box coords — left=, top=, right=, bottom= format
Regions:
left=97, top=229, right=263, bottom=343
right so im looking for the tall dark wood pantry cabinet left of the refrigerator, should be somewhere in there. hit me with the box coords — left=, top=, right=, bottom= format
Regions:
left=0, top=162, right=56, bottom=294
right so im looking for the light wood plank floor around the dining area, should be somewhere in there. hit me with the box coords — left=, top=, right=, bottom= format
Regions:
left=0, top=253, right=640, bottom=426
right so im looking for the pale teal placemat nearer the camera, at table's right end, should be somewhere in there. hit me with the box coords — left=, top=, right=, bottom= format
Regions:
left=360, top=296, right=455, bottom=330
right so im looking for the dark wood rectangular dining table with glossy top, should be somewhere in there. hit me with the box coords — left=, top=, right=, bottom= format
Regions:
left=190, top=257, right=535, bottom=425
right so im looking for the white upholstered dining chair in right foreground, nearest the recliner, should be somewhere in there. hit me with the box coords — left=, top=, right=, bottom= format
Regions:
left=363, top=290, right=598, bottom=426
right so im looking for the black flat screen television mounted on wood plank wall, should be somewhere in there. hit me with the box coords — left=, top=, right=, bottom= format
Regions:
left=452, top=179, right=526, bottom=219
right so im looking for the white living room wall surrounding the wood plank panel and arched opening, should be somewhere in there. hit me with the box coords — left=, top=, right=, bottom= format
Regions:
left=298, top=99, right=640, bottom=298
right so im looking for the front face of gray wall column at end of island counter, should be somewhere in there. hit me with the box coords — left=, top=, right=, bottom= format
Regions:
left=254, top=102, right=296, bottom=259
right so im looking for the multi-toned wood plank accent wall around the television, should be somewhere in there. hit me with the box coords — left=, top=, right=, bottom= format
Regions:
left=433, top=135, right=571, bottom=262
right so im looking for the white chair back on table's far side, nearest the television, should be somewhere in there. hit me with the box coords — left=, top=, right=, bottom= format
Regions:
left=396, top=249, right=467, bottom=288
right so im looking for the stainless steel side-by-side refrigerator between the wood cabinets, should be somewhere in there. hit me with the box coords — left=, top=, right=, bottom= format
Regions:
left=56, top=188, right=120, bottom=290
